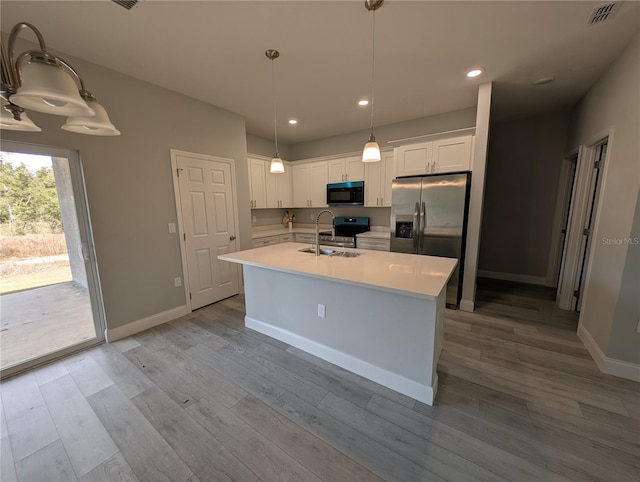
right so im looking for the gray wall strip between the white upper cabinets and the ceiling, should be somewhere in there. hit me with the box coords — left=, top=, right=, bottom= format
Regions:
left=287, top=106, right=476, bottom=161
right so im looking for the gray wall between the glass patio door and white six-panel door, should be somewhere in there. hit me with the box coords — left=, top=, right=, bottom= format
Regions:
left=2, top=41, right=251, bottom=328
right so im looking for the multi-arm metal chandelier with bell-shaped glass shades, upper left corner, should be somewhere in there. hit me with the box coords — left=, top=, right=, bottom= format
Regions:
left=0, top=22, right=120, bottom=136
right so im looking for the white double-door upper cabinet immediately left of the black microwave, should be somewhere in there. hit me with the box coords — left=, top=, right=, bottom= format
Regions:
left=291, top=161, right=329, bottom=208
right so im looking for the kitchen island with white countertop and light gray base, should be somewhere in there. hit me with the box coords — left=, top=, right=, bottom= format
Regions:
left=219, top=243, right=457, bottom=405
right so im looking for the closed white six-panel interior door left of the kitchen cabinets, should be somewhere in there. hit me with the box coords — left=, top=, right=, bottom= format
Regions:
left=172, top=151, right=239, bottom=310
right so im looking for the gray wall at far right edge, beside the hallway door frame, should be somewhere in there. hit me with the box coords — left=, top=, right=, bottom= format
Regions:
left=567, top=34, right=640, bottom=363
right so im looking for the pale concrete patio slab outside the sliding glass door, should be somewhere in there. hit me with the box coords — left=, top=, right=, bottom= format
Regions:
left=0, top=281, right=96, bottom=369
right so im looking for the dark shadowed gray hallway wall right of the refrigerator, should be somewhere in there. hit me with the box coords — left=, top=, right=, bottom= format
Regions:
left=479, top=112, right=569, bottom=278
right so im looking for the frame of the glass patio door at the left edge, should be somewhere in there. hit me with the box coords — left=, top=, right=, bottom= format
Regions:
left=0, top=140, right=107, bottom=379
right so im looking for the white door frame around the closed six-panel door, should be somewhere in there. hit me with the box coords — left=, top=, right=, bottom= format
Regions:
left=169, top=149, right=242, bottom=313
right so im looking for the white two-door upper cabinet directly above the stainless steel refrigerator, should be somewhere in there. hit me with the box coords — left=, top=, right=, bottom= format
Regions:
left=396, top=135, right=473, bottom=176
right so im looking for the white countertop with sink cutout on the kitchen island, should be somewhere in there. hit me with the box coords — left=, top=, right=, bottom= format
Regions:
left=218, top=243, right=457, bottom=298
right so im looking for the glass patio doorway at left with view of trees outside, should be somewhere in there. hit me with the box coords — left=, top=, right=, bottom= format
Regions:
left=0, top=142, right=104, bottom=378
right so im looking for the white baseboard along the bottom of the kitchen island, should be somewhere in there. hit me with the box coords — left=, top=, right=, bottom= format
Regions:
left=244, top=316, right=438, bottom=405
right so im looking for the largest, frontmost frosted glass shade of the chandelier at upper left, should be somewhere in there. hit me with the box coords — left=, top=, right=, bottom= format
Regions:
left=11, top=61, right=95, bottom=117
